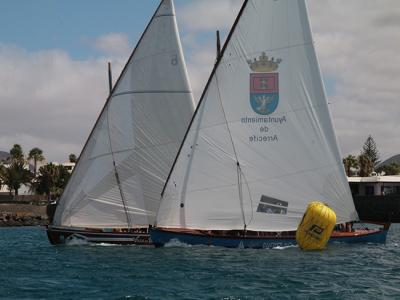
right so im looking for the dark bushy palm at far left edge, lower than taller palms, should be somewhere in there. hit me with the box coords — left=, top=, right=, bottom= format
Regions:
left=0, top=160, right=32, bottom=196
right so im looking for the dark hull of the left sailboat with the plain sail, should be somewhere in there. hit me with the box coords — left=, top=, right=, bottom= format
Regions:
left=47, top=225, right=152, bottom=246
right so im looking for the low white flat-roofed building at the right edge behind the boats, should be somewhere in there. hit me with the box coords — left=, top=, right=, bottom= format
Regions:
left=347, top=175, right=400, bottom=196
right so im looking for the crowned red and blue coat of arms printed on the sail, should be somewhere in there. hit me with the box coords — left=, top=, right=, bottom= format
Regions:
left=247, top=52, right=282, bottom=115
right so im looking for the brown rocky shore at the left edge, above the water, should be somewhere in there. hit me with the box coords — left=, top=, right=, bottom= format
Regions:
left=0, top=204, right=49, bottom=227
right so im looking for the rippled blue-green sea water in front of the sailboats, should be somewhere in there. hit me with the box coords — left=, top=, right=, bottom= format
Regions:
left=0, top=225, right=400, bottom=300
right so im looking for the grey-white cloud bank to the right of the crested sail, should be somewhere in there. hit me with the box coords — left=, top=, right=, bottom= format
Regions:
left=309, top=0, right=400, bottom=158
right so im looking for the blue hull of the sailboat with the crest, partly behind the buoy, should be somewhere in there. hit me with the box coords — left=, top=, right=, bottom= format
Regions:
left=150, top=228, right=387, bottom=248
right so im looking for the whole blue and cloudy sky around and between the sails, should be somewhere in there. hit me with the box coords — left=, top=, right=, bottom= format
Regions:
left=0, top=0, right=400, bottom=162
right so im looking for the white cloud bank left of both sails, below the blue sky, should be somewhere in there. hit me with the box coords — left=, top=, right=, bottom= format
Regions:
left=0, top=44, right=125, bottom=161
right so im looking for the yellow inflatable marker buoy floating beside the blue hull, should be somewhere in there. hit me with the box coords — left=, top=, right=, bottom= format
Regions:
left=296, top=202, right=336, bottom=250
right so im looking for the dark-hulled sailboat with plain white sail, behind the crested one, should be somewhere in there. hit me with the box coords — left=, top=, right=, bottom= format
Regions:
left=47, top=0, right=194, bottom=244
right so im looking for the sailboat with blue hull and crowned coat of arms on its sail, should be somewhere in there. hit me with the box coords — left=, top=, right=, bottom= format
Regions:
left=151, top=0, right=388, bottom=248
